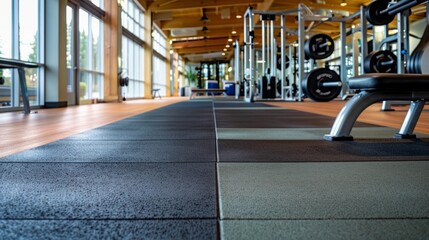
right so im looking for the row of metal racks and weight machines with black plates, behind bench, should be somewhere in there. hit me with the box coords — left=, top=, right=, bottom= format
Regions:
left=235, top=0, right=423, bottom=102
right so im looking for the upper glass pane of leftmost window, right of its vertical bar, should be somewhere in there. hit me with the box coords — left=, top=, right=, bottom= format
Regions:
left=19, top=0, right=39, bottom=62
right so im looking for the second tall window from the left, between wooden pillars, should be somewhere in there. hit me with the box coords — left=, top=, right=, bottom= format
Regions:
left=79, top=9, right=104, bottom=99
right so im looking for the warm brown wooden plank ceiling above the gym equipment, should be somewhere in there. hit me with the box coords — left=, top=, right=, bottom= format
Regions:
left=148, top=0, right=426, bottom=62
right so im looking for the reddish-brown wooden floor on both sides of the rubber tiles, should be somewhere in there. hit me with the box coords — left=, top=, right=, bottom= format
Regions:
left=0, top=97, right=429, bottom=157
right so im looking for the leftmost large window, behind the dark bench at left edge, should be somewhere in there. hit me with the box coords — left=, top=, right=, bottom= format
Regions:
left=0, top=0, right=44, bottom=108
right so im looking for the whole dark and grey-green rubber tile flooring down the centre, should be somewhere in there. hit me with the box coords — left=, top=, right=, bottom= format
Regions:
left=0, top=100, right=429, bottom=239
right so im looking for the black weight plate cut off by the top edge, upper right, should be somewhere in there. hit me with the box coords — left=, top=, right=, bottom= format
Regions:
left=365, top=0, right=395, bottom=26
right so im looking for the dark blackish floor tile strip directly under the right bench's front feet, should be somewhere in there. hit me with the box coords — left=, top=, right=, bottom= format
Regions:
left=218, top=139, right=429, bottom=162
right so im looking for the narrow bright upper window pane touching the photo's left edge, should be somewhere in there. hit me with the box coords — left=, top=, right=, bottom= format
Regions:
left=0, top=1, right=12, bottom=58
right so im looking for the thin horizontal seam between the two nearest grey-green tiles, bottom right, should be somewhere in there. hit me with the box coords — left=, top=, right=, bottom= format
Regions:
left=220, top=216, right=429, bottom=221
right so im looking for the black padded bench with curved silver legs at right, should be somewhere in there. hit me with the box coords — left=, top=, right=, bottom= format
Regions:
left=324, top=73, right=429, bottom=141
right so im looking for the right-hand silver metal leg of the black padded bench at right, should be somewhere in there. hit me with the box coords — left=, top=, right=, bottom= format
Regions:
left=395, top=100, right=425, bottom=139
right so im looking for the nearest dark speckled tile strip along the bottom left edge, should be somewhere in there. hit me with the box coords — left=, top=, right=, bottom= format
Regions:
left=0, top=219, right=216, bottom=240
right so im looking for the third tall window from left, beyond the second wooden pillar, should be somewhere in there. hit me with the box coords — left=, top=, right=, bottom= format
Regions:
left=121, top=0, right=144, bottom=98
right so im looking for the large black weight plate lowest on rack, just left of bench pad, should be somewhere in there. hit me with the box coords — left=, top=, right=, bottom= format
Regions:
left=302, top=68, right=341, bottom=102
